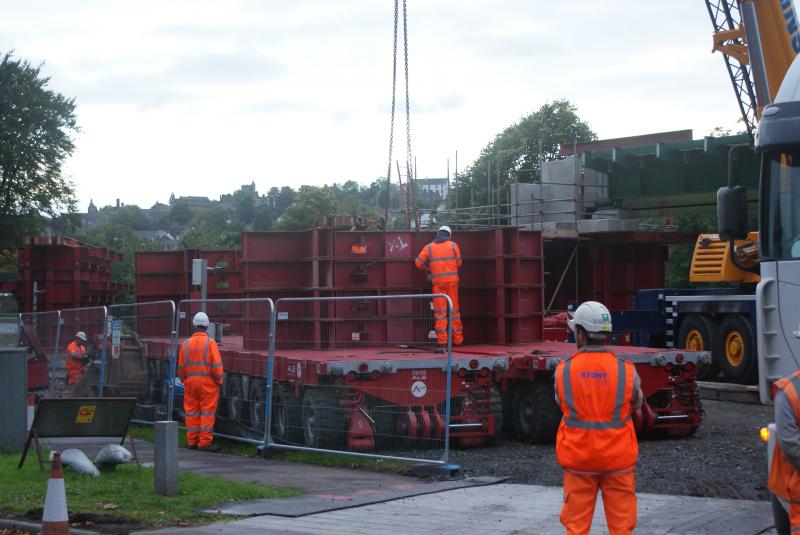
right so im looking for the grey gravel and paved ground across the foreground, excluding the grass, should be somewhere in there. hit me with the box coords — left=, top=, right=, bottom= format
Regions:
left=1, top=401, right=773, bottom=535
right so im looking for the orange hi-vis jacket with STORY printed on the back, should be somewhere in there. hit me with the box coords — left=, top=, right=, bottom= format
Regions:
left=556, top=348, right=639, bottom=475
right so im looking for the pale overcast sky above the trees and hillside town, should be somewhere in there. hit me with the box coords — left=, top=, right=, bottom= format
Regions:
left=0, top=0, right=738, bottom=210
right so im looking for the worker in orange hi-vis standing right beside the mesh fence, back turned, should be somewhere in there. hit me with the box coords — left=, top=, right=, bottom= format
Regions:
left=178, top=312, right=223, bottom=451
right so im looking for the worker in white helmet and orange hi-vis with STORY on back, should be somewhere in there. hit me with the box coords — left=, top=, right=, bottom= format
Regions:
left=555, top=301, right=643, bottom=535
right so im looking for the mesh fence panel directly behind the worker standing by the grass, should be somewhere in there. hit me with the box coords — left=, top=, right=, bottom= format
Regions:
left=170, top=299, right=273, bottom=444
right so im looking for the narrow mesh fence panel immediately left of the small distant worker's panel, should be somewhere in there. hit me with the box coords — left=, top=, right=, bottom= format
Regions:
left=19, top=310, right=61, bottom=396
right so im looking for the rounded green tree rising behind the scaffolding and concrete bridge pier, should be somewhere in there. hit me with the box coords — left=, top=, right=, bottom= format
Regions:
left=448, top=100, right=597, bottom=206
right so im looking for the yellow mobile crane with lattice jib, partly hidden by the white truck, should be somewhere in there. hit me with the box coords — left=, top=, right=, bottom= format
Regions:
left=671, top=0, right=800, bottom=383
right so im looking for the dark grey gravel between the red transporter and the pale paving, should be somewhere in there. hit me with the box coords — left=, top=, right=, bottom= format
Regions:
left=450, top=401, right=773, bottom=500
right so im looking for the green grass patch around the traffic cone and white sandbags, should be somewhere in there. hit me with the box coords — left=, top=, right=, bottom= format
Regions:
left=0, top=455, right=303, bottom=526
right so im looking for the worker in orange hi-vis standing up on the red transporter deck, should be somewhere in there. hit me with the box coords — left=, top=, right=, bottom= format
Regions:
left=414, top=225, right=464, bottom=346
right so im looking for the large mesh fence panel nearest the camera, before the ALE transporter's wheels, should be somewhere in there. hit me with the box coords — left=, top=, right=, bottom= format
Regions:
left=268, top=294, right=456, bottom=462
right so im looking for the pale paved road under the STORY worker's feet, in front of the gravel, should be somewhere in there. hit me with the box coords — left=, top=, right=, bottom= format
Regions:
left=136, top=484, right=774, bottom=535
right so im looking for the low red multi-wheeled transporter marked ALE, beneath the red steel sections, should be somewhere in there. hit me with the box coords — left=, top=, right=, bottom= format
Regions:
left=141, top=336, right=704, bottom=451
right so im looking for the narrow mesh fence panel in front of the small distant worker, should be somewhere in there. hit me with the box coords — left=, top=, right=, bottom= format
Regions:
left=56, top=306, right=108, bottom=397
